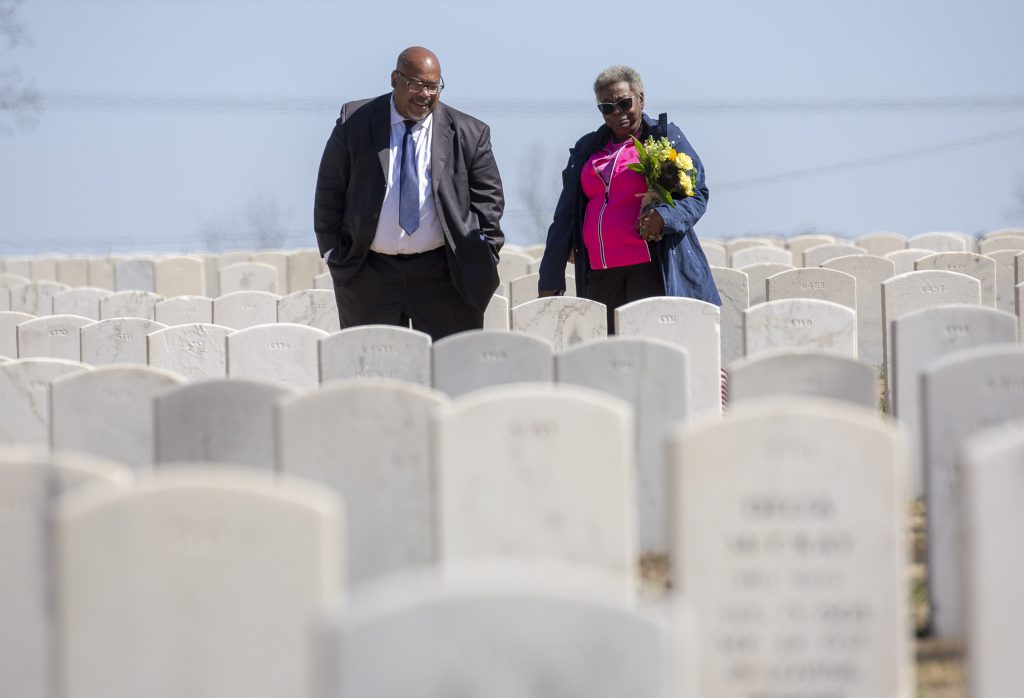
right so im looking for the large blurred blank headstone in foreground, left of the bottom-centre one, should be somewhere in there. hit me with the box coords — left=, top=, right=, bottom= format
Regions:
left=55, top=468, right=341, bottom=698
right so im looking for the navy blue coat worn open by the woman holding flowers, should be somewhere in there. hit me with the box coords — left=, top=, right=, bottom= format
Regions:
left=538, top=114, right=722, bottom=305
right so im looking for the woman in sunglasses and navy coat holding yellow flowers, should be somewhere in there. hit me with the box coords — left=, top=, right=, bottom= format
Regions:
left=538, top=66, right=721, bottom=332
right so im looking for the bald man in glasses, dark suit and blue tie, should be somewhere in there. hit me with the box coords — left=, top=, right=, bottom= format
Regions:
left=313, top=46, right=505, bottom=340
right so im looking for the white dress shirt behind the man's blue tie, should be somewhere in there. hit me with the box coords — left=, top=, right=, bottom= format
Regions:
left=370, top=96, right=444, bottom=255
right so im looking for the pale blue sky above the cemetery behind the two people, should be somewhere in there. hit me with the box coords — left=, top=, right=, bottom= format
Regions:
left=0, top=0, right=1024, bottom=254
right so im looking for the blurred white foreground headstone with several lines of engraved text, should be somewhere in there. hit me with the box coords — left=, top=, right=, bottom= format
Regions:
left=670, top=398, right=913, bottom=698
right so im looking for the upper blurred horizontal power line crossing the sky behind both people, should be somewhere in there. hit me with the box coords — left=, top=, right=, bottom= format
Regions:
left=43, top=90, right=1024, bottom=117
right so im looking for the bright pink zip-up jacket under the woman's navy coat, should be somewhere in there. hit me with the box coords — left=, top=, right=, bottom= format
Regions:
left=580, top=138, right=651, bottom=269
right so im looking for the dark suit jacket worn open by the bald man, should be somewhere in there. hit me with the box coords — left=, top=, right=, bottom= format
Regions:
left=313, top=93, right=505, bottom=311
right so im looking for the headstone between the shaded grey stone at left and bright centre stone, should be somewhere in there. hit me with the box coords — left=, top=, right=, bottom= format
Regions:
left=276, top=379, right=447, bottom=584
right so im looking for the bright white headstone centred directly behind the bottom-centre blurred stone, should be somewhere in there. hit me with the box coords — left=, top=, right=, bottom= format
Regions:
left=436, top=385, right=637, bottom=586
